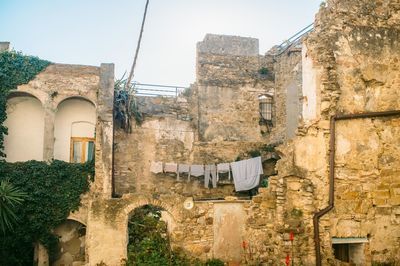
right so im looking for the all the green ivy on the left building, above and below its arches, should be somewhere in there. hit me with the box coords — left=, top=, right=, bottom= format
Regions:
left=0, top=51, right=94, bottom=265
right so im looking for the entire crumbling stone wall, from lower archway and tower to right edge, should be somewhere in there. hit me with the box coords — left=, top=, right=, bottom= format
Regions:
left=88, top=0, right=400, bottom=265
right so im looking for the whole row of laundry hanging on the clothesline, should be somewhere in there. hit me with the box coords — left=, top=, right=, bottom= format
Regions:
left=150, top=156, right=263, bottom=191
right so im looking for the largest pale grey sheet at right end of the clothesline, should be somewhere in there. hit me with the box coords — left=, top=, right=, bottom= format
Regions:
left=231, top=157, right=263, bottom=191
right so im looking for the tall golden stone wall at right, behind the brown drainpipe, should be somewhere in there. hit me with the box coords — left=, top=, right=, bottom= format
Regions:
left=277, top=0, right=400, bottom=264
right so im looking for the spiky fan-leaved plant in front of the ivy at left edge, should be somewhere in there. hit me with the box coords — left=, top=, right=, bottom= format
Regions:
left=0, top=180, right=27, bottom=233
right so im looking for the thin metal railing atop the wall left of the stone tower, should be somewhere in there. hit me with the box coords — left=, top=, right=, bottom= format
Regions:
left=132, top=82, right=188, bottom=97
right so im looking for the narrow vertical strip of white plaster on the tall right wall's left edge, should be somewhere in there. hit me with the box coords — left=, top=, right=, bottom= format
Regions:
left=302, top=44, right=319, bottom=123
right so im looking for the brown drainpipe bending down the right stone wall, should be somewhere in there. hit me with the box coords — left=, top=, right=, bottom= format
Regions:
left=313, top=110, right=400, bottom=266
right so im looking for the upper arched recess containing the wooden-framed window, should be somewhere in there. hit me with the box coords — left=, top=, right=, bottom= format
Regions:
left=54, top=97, right=96, bottom=163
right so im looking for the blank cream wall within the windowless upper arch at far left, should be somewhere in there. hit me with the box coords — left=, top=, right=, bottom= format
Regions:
left=4, top=96, right=44, bottom=162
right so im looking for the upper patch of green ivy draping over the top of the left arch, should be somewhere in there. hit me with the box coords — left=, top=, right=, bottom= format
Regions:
left=0, top=51, right=51, bottom=158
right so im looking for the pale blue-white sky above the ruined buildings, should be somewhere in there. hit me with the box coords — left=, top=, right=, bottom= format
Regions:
left=0, top=0, right=321, bottom=86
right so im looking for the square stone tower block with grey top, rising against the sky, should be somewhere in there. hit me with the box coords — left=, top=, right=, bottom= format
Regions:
left=194, top=34, right=274, bottom=141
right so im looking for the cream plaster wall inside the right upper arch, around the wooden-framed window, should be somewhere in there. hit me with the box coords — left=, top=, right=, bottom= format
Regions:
left=54, top=98, right=96, bottom=162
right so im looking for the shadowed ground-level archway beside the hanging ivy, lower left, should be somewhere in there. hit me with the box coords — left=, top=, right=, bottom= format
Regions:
left=51, top=220, right=86, bottom=266
